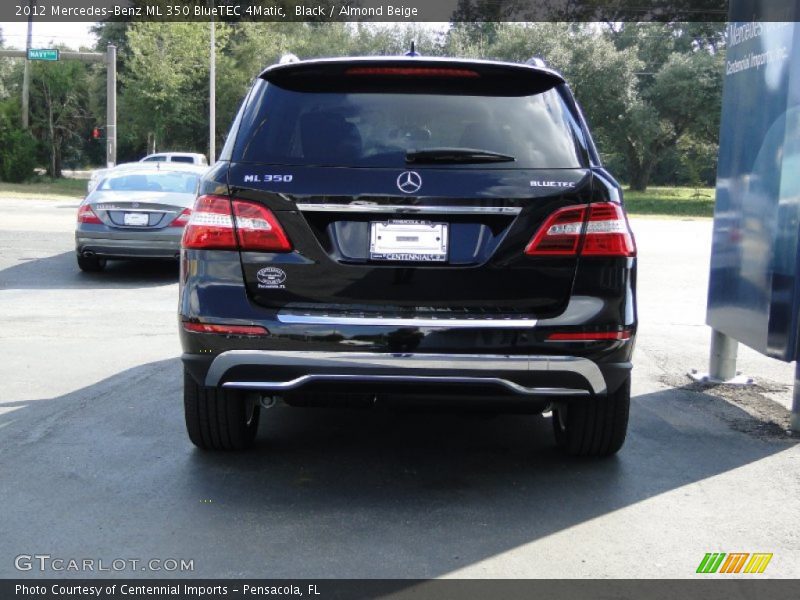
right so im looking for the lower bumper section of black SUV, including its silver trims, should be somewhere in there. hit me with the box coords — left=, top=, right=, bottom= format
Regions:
left=183, top=350, right=631, bottom=397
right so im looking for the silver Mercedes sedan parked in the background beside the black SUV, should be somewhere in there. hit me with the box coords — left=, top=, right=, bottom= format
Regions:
left=75, top=163, right=208, bottom=271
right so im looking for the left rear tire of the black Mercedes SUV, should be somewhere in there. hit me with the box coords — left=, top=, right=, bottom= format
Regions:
left=183, top=369, right=261, bottom=450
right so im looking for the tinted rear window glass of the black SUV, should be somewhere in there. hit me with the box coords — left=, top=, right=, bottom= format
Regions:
left=233, top=81, right=585, bottom=169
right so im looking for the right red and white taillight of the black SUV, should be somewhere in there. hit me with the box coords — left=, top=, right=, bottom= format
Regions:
left=525, top=202, right=636, bottom=256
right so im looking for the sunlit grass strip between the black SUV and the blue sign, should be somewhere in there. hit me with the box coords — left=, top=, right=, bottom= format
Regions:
left=623, top=187, right=714, bottom=217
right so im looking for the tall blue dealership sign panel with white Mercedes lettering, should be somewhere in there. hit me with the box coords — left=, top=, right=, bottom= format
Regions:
left=707, top=0, right=800, bottom=361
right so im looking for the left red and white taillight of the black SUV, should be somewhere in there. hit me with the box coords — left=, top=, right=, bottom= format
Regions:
left=183, top=196, right=292, bottom=252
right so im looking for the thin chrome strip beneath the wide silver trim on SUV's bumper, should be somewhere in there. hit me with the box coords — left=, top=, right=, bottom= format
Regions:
left=222, top=374, right=589, bottom=396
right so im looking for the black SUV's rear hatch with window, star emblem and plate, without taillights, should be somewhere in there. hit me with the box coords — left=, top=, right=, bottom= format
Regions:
left=228, top=59, right=595, bottom=318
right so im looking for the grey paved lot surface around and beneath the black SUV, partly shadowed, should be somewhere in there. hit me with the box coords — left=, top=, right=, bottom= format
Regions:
left=0, top=198, right=800, bottom=578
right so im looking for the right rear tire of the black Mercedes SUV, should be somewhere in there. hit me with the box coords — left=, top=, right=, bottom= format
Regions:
left=553, top=375, right=631, bottom=456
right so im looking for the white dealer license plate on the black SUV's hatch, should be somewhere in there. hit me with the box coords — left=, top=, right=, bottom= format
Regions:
left=369, top=220, right=447, bottom=262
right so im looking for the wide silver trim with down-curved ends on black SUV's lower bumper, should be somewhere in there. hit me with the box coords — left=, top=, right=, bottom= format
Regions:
left=205, top=350, right=606, bottom=394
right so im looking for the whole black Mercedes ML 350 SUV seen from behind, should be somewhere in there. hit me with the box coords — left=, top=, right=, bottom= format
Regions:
left=180, top=56, right=636, bottom=456
